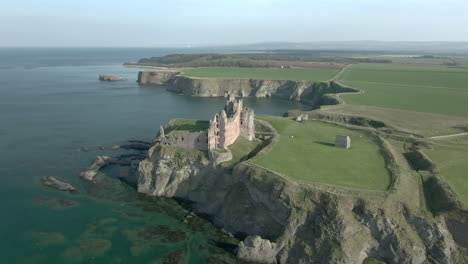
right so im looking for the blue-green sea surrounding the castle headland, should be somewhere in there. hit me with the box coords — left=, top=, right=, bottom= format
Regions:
left=0, top=48, right=304, bottom=264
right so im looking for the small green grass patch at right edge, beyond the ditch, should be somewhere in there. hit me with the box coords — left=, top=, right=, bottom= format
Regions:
left=424, top=136, right=468, bottom=207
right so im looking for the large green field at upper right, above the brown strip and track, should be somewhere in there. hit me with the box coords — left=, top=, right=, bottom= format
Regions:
left=338, top=65, right=468, bottom=117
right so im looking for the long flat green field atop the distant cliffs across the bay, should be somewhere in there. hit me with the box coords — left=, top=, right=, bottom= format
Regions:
left=184, top=67, right=340, bottom=81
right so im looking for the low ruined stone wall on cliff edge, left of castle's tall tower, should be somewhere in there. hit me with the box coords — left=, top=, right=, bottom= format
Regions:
left=160, top=131, right=208, bottom=150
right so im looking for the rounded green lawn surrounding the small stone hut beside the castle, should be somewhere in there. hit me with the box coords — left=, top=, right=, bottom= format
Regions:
left=252, top=117, right=390, bottom=190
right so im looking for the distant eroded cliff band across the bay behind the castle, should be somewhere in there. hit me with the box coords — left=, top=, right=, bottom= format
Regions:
left=138, top=70, right=358, bottom=106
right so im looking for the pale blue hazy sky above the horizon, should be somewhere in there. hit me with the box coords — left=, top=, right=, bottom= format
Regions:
left=0, top=0, right=468, bottom=47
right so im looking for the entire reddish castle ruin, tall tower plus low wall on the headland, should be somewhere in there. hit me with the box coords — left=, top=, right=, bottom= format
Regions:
left=159, top=95, right=255, bottom=156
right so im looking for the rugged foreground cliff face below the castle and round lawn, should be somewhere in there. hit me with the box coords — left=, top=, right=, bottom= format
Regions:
left=138, top=145, right=467, bottom=264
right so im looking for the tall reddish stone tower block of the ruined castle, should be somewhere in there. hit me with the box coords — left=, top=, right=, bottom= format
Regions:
left=208, top=95, right=255, bottom=150
